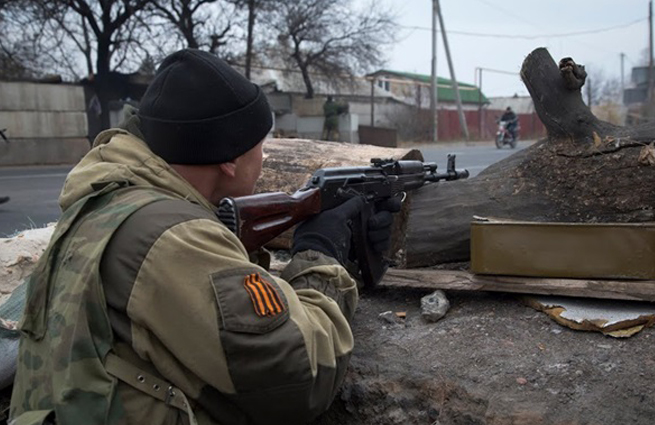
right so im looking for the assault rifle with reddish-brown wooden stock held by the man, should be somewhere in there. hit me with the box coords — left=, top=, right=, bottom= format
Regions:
left=217, top=155, right=469, bottom=285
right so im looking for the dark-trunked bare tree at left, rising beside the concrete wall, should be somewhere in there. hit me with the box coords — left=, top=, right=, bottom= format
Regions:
left=9, top=0, right=152, bottom=128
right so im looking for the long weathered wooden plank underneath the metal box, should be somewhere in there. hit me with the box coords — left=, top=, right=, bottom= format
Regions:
left=379, top=269, right=655, bottom=302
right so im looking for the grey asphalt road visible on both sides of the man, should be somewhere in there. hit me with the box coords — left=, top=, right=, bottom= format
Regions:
left=0, top=142, right=531, bottom=238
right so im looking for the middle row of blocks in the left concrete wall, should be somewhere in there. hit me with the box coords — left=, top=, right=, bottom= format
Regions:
left=0, top=111, right=88, bottom=140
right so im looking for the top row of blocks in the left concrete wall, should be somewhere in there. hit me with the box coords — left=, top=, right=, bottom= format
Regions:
left=0, top=82, right=86, bottom=111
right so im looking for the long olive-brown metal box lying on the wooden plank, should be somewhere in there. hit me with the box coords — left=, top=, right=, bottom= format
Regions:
left=471, top=217, right=655, bottom=279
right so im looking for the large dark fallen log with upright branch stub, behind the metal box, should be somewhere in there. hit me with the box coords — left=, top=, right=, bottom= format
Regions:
left=399, top=48, right=655, bottom=268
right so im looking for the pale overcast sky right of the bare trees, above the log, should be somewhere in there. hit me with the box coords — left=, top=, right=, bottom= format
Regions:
left=378, top=0, right=649, bottom=96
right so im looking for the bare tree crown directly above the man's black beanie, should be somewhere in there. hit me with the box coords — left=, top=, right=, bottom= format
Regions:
left=152, top=0, right=236, bottom=53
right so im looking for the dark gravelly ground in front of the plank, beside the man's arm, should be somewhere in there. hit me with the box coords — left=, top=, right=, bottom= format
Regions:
left=316, top=288, right=655, bottom=425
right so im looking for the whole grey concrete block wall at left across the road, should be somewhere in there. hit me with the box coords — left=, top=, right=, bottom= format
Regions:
left=0, top=82, right=89, bottom=165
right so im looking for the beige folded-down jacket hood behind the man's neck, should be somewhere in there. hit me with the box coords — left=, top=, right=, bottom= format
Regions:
left=59, top=127, right=215, bottom=211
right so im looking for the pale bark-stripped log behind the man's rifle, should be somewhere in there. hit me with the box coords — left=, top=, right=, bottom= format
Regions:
left=255, top=139, right=423, bottom=253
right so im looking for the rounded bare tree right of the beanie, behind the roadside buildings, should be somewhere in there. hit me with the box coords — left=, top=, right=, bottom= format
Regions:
left=269, top=0, right=396, bottom=99
